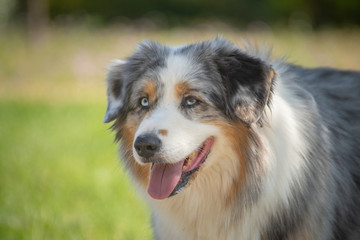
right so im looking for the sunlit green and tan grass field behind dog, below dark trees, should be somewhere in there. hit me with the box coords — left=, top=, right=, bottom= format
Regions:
left=0, top=27, right=360, bottom=239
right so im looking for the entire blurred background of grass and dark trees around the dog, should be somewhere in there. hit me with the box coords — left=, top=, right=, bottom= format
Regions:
left=0, top=0, right=360, bottom=240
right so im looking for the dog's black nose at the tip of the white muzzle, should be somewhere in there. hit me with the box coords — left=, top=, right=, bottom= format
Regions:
left=134, top=134, right=161, bottom=158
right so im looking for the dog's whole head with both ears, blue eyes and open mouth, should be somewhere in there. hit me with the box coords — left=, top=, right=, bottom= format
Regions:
left=104, top=38, right=274, bottom=199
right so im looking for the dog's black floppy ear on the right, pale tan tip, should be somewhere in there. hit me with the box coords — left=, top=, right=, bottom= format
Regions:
left=215, top=43, right=275, bottom=125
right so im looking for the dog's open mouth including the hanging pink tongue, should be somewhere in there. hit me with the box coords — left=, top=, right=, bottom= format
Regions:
left=148, top=137, right=214, bottom=199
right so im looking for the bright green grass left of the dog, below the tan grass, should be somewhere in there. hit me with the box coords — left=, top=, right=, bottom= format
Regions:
left=0, top=101, right=152, bottom=239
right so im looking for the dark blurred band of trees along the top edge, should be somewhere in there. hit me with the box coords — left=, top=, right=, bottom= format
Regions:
left=12, top=0, right=360, bottom=27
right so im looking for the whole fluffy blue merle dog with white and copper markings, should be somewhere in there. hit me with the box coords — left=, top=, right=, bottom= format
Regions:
left=104, top=37, right=360, bottom=240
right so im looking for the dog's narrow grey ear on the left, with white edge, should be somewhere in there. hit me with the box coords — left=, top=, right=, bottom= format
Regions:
left=104, top=59, right=126, bottom=123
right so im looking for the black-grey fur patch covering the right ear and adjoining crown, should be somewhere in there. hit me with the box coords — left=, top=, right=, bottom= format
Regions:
left=175, top=38, right=274, bottom=124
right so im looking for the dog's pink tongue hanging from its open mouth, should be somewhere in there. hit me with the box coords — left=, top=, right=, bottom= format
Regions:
left=148, top=160, right=185, bottom=199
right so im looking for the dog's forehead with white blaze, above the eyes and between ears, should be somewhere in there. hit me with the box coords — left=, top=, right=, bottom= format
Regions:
left=131, top=45, right=222, bottom=105
